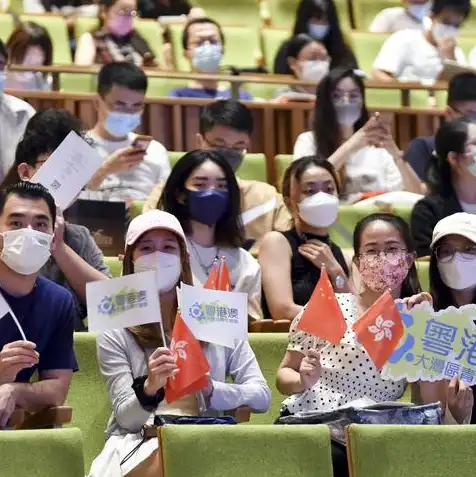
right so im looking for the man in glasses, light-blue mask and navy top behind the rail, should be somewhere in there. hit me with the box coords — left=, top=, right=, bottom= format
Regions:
left=169, top=17, right=253, bottom=100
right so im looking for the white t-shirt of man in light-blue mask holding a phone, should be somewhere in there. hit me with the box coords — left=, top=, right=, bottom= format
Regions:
left=80, top=131, right=171, bottom=201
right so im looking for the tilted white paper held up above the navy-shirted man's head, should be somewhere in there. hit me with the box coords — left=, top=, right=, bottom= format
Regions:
left=31, top=131, right=104, bottom=210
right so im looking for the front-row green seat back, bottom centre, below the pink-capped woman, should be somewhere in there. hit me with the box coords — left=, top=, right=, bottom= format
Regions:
left=161, top=425, right=332, bottom=477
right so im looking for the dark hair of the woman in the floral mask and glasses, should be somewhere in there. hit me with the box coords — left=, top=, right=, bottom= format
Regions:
left=354, top=213, right=421, bottom=298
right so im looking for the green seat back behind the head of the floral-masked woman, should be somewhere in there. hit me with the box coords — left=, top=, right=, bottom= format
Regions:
left=329, top=205, right=412, bottom=248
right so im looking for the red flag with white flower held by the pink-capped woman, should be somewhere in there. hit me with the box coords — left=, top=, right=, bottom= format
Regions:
left=165, top=312, right=210, bottom=404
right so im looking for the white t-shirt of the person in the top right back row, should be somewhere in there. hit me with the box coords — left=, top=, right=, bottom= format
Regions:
left=373, top=30, right=466, bottom=81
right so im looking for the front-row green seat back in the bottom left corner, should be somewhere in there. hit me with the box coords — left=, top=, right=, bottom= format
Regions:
left=0, top=429, right=85, bottom=477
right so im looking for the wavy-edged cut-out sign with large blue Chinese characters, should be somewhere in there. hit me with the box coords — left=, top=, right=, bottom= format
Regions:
left=382, top=303, right=476, bottom=385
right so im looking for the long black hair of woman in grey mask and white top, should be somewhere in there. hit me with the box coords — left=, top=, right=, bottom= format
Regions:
left=314, top=68, right=369, bottom=158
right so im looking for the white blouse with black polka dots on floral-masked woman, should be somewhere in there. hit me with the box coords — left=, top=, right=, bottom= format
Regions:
left=283, top=293, right=406, bottom=414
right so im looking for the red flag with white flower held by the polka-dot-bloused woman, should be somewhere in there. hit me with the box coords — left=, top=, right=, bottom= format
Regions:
left=352, top=290, right=404, bottom=369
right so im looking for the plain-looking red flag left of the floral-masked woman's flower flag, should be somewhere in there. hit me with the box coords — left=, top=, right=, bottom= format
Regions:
left=297, top=268, right=347, bottom=344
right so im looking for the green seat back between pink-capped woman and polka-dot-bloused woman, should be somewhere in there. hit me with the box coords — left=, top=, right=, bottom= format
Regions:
left=248, top=333, right=288, bottom=424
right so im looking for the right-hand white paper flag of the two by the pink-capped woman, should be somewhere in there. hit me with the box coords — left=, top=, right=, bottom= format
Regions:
left=180, top=283, right=248, bottom=348
